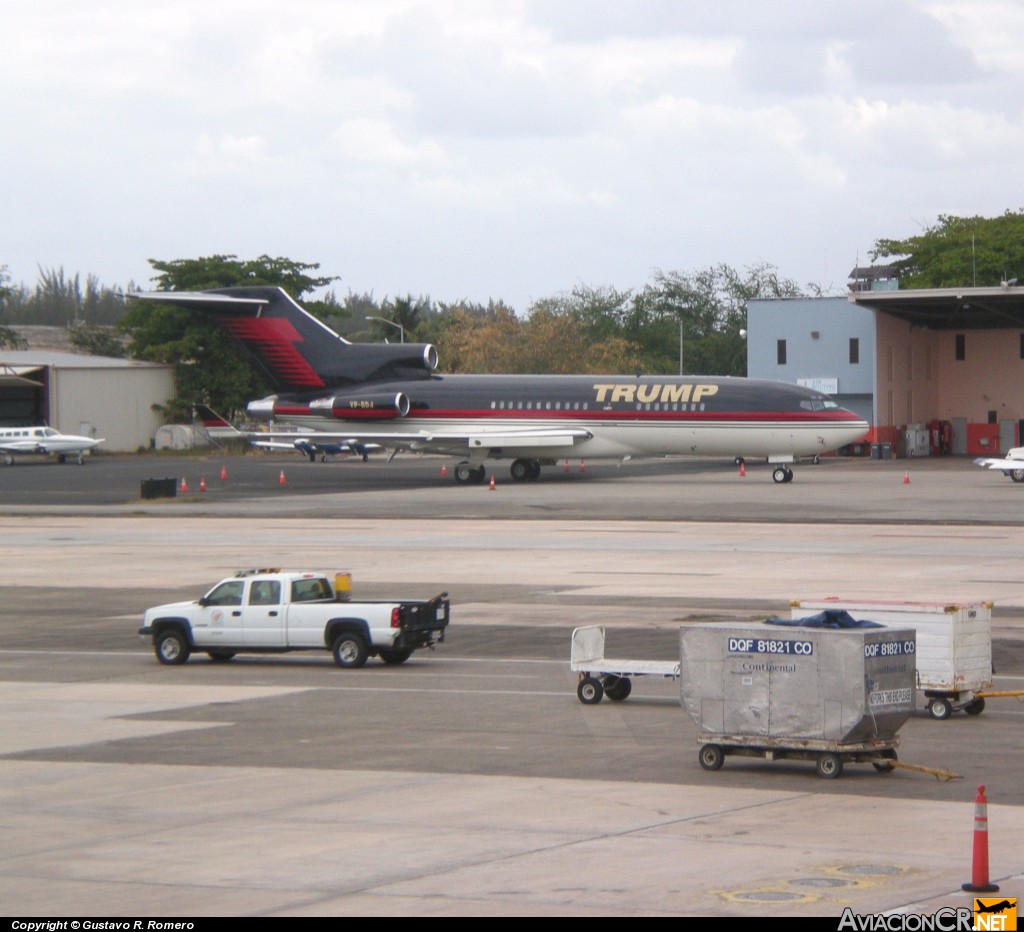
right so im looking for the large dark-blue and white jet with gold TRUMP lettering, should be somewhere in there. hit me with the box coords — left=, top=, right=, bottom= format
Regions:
left=123, top=287, right=868, bottom=483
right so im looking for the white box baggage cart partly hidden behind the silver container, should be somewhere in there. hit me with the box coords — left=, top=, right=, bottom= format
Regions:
left=790, top=598, right=991, bottom=721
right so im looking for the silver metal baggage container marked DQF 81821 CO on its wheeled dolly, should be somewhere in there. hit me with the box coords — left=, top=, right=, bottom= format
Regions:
left=680, top=625, right=916, bottom=779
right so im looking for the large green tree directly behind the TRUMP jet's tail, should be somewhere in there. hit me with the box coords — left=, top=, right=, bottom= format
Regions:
left=119, top=255, right=335, bottom=419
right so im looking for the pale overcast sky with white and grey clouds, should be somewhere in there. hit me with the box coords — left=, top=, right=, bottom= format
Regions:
left=0, top=0, right=1024, bottom=311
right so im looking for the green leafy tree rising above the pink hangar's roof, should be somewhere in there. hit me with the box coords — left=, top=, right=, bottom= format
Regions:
left=870, top=210, right=1024, bottom=288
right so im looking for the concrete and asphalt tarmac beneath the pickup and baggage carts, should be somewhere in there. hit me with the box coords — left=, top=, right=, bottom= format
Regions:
left=0, top=457, right=1024, bottom=919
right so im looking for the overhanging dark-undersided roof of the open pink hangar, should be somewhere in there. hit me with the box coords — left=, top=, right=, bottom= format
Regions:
left=847, top=285, right=1024, bottom=331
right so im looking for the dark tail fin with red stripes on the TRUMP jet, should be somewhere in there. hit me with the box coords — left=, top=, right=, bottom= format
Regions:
left=129, top=286, right=437, bottom=392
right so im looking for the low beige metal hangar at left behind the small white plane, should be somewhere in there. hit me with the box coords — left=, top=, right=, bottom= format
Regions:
left=0, top=349, right=175, bottom=453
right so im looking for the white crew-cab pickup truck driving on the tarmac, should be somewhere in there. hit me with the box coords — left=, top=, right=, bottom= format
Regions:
left=138, top=569, right=450, bottom=668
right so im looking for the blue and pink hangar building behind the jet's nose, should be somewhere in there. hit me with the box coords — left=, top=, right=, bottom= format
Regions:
left=746, top=269, right=1024, bottom=457
